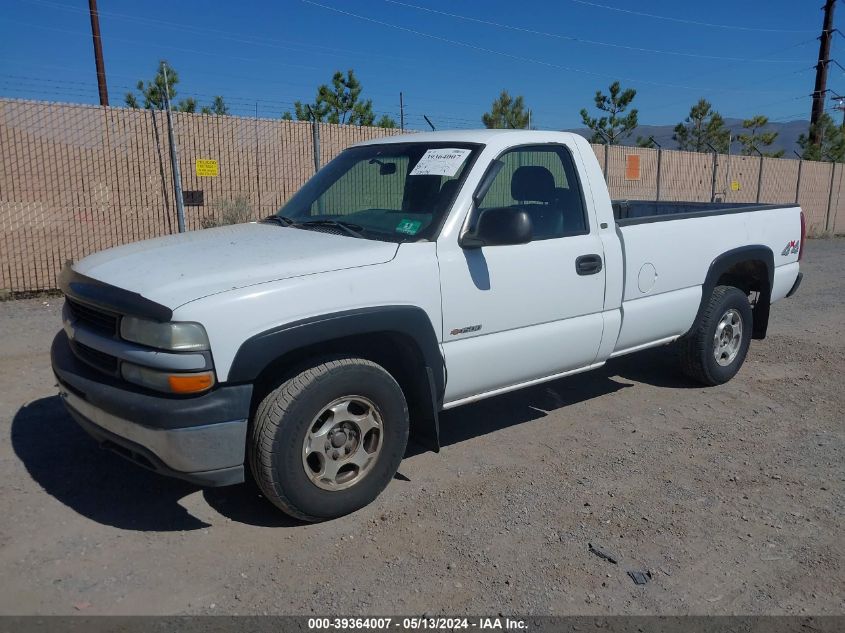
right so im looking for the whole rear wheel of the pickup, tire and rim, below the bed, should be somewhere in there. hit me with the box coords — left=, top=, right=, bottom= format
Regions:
left=679, top=286, right=753, bottom=385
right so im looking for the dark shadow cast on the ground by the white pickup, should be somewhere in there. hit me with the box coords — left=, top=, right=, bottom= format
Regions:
left=11, top=350, right=698, bottom=532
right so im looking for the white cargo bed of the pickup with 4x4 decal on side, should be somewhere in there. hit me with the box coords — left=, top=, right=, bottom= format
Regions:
left=613, top=201, right=800, bottom=355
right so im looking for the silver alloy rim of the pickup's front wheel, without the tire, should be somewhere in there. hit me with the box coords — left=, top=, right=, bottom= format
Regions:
left=302, top=396, right=384, bottom=490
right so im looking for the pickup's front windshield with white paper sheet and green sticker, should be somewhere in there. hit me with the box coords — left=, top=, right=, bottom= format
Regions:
left=276, top=143, right=481, bottom=241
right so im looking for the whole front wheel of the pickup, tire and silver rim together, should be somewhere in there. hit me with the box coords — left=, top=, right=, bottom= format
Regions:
left=247, top=358, right=409, bottom=521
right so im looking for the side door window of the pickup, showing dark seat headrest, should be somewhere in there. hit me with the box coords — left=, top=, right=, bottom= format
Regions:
left=478, top=145, right=588, bottom=240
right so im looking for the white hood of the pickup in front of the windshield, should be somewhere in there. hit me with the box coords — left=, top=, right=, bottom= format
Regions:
left=73, top=223, right=398, bottom=309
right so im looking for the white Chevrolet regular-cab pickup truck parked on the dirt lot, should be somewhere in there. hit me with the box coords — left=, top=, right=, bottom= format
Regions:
left=52, top=130, right=804, bottom=521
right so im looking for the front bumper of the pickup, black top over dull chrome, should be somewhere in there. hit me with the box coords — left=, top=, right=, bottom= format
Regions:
left=50, top=332, right=252, bottom=486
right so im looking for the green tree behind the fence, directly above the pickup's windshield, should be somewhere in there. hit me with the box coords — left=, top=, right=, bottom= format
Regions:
left=282, top=69, right=396, bottom=127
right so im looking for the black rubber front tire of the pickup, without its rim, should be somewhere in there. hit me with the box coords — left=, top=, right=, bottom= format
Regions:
left=247, top=357, right=409, bottom=521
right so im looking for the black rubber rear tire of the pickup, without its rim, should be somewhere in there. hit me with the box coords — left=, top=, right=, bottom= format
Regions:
left=679, top=286, right=754, bottom=386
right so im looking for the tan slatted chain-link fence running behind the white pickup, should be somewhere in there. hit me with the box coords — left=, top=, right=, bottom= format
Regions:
left=0, top=99, right=845, bottom=292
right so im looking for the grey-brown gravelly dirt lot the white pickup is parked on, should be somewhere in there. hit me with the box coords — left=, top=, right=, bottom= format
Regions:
left=0, top=240, right=845, bottom=615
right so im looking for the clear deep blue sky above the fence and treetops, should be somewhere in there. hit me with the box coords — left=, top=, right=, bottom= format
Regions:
left=0, top=0, right=845, bottom=129
